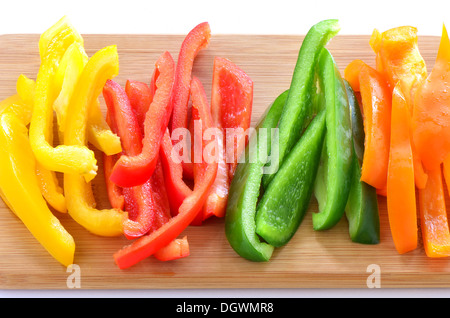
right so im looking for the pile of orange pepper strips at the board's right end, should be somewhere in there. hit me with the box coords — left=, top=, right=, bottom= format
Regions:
left=344, top=26, right=450, bottom=257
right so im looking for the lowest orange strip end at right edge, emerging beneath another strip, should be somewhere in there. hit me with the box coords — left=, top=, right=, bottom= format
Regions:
left=419, top=165, right=450, bottom=258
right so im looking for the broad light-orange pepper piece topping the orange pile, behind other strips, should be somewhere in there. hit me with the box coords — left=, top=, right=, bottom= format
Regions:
left=370, top=26, right=427, bottom=189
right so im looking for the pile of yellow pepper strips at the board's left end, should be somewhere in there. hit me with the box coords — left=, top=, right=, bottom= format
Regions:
left=0, top=17, right=126, bottom=266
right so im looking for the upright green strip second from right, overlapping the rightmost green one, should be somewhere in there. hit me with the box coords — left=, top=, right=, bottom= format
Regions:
left=312, top=48, right=353, bottom=230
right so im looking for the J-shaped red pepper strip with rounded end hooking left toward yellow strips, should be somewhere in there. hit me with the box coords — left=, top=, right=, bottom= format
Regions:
left=111, top=52, right=175, bottom=187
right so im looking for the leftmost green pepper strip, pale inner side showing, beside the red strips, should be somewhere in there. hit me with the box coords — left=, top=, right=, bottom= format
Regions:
left=225, top=91, right=288, bottom=262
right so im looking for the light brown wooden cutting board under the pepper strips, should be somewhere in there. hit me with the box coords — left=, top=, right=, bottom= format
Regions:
left=0, top=34, right=450, bottom=289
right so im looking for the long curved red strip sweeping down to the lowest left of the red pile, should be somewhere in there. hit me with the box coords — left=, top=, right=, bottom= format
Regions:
left=114, top=77, right=217, bottom=269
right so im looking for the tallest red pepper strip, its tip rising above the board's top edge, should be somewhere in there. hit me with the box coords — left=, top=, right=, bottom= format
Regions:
left=171, top=22, right=211, bottom=178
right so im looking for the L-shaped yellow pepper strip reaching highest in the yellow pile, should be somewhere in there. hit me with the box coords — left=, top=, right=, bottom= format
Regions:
left=29, top=18, right=97, bottom=181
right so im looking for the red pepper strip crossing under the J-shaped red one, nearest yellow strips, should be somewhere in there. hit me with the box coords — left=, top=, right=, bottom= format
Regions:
left=103, top=80, right=170, bottom=239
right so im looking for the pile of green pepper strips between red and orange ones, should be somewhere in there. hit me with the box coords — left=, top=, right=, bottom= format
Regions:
left=225, top=20, right=380, bottom=261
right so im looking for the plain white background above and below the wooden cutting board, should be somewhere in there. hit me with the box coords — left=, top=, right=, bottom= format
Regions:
left=0, top=0, right=450, bottom=297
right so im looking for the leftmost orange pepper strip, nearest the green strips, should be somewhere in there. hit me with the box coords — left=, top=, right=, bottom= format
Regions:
left=344, top=61, right=392, bottom=190
